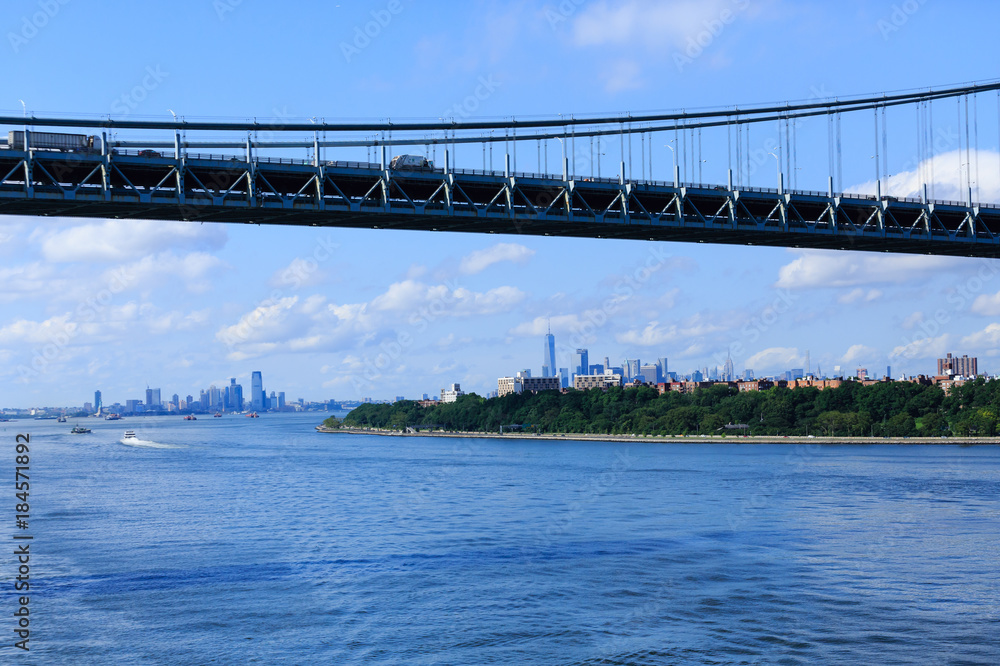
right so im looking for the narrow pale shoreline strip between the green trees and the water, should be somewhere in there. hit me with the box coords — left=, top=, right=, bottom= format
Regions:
left=316, top=425, right=1000, bottom=446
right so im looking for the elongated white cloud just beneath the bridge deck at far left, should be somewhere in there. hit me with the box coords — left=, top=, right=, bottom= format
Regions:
left=42, top=220, right=227, bottom=262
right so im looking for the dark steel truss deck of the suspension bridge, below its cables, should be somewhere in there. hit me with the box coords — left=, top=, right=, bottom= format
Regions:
left=0, top=148, right=1000, bottom=257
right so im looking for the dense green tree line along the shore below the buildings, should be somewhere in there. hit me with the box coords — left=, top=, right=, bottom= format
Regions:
left=326, top=378, right=1000, bottom=437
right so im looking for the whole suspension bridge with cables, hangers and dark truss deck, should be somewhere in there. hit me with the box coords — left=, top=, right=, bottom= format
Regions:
left=0, top=82, right=1000, bottom=257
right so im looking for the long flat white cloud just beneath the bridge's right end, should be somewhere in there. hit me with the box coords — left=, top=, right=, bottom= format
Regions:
left=775, top=250, right=968, bottom=293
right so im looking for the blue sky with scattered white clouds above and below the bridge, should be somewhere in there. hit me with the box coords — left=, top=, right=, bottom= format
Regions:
left=0, top=0, right=1000, bottom=407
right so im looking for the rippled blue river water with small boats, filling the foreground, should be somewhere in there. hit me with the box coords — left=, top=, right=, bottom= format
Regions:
left=0, top=414, right=1000, bottom=664
